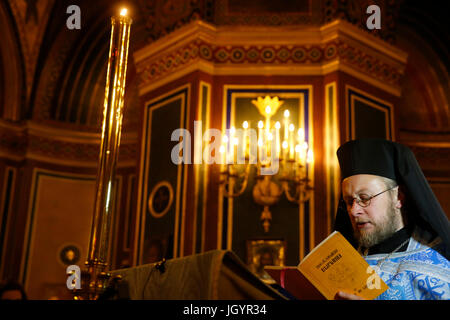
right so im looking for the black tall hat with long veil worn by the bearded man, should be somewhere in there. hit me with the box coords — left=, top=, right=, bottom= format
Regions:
left=335, top=139, right=450, bottom=258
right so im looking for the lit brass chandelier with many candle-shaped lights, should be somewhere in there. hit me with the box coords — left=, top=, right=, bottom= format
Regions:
left=219, top=96, right=314, bottom=233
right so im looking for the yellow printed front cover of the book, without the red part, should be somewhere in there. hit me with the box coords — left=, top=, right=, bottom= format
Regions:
left=297, top=231, right=389, bottom=300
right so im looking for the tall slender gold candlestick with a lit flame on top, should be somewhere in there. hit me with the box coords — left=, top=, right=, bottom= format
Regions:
left=85, top=9, right=132, bottom=299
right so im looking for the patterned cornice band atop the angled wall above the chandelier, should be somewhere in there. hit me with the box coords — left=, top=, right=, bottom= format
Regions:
left=134, top=20, right=407, bottom=95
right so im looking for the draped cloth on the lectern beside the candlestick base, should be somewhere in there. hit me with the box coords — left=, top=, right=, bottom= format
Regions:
left=111, top=250, right=286, bottom=300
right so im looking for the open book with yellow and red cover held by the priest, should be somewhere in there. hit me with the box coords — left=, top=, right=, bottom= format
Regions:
left=264, top=231, right=388, bottom=300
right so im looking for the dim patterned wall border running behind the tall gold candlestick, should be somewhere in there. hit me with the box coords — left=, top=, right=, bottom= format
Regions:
left=0, top=120, right=138, bottom=167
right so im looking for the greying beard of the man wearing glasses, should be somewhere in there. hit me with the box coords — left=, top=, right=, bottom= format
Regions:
left=353, top=202, right=399, bottom=248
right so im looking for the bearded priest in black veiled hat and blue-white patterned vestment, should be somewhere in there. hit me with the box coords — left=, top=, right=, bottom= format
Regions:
left=335, top=139, right=450, bottom=300
